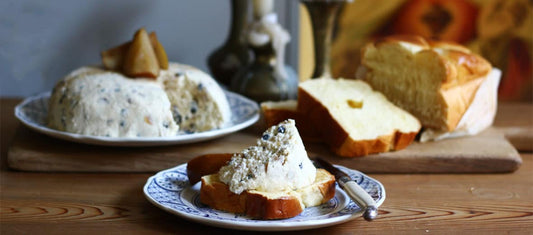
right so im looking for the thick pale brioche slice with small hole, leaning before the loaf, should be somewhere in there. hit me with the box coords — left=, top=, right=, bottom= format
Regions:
left=297, top=79, right=421, bottom=157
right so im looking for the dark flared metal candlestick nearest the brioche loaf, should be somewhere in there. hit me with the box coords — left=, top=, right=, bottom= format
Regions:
left=300, top=0, right=344, bottom=78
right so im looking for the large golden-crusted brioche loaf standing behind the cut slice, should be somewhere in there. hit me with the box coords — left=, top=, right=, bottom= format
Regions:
left=357, top=35, right=492, bottom=131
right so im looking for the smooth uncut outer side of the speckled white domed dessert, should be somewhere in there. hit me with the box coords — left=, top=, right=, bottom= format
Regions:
left=49, top=67, right=178, bottom=137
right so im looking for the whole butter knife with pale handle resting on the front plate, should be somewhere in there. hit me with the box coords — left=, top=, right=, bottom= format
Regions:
left=314, top=158, right=378, bottom=221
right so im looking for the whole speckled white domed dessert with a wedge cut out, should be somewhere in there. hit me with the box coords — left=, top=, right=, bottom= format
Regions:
left=48, top=63, right=231, bottom=137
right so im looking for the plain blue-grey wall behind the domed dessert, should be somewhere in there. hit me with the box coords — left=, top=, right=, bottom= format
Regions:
left=0, top=0, right=299, bottom=97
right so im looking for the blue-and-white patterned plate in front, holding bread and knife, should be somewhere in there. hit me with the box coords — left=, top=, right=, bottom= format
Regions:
left=143, top=164, right=385, bottom=231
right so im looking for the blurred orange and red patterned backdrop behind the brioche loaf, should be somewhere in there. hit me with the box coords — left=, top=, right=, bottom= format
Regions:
left=322, top=0, right=533, bottom=102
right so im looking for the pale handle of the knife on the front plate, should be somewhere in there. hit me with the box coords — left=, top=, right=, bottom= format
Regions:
left=340, top=180, right=378, bottom=221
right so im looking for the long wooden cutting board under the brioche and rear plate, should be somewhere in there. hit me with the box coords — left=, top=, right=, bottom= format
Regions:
left=8, top=125, right=522, bottom=173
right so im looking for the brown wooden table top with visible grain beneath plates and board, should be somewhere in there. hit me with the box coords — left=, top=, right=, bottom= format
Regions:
left=0, top=98, right=533, bottom=234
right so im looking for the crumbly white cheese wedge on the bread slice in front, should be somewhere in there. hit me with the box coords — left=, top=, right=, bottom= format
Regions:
left=219, top=119, right=316, bottom=194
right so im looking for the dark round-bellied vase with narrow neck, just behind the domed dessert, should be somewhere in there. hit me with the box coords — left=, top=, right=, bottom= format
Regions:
left=207, top=0, right=250, bottom=86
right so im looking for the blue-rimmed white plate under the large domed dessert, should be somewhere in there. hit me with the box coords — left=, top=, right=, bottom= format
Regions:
left=15, top=91, right=259, bottom=147
